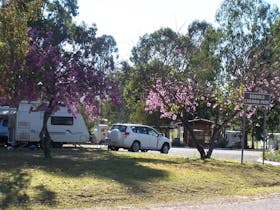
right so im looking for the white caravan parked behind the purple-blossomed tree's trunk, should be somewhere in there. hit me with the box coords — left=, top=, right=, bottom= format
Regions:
left=9, top=102, right=89, bottom=147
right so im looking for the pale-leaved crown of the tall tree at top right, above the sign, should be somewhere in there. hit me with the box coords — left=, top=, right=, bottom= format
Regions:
left=216, top=0, right=279, bottom=82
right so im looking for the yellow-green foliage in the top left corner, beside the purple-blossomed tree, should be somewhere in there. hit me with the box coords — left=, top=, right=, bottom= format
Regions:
left=0, top=0, right=42, bottom=105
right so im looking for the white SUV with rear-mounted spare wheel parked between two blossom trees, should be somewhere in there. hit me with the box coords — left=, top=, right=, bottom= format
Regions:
left=108, top=124, right=171, bottom=154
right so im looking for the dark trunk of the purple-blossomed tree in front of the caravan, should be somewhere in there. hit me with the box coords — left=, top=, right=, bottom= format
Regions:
left=39, top=110, right=52, bottom=159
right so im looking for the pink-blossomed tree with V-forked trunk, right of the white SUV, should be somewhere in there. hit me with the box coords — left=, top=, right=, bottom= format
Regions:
left=146, top=74, right=242, bottom=159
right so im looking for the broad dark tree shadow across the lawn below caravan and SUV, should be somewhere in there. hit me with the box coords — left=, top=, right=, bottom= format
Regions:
left=0, top=148, right=172, bottom=198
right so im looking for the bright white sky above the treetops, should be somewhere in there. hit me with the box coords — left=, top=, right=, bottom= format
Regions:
left=75, top=0, right=280, bottom=60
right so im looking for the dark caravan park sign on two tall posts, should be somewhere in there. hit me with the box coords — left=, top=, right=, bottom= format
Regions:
left=241, top=92, right=270, bottom=164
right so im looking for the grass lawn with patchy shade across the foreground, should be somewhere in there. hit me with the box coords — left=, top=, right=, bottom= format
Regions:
left=0, top=148, right=280, bottom=209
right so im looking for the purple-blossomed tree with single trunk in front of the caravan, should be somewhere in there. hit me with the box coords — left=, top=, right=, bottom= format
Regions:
left=9, top=29, right=120, bottom=158
